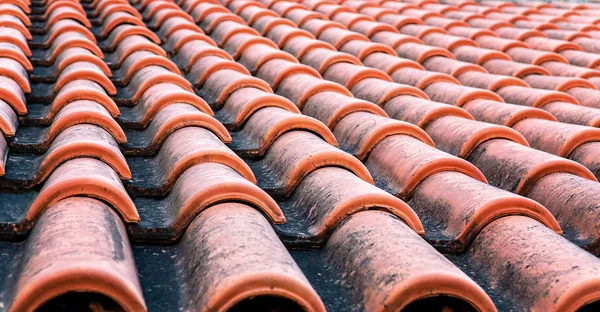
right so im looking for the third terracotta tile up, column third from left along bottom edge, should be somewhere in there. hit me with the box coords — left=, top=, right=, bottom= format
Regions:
left=251, top=131, right=373, bottom=199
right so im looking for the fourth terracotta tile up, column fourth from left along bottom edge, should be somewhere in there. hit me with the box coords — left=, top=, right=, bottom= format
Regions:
left=334, top=112, right=434, bottom=161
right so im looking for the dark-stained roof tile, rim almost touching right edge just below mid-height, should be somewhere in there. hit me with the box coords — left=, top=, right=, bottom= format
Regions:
left=468, top=140, right=595, bottom=194
